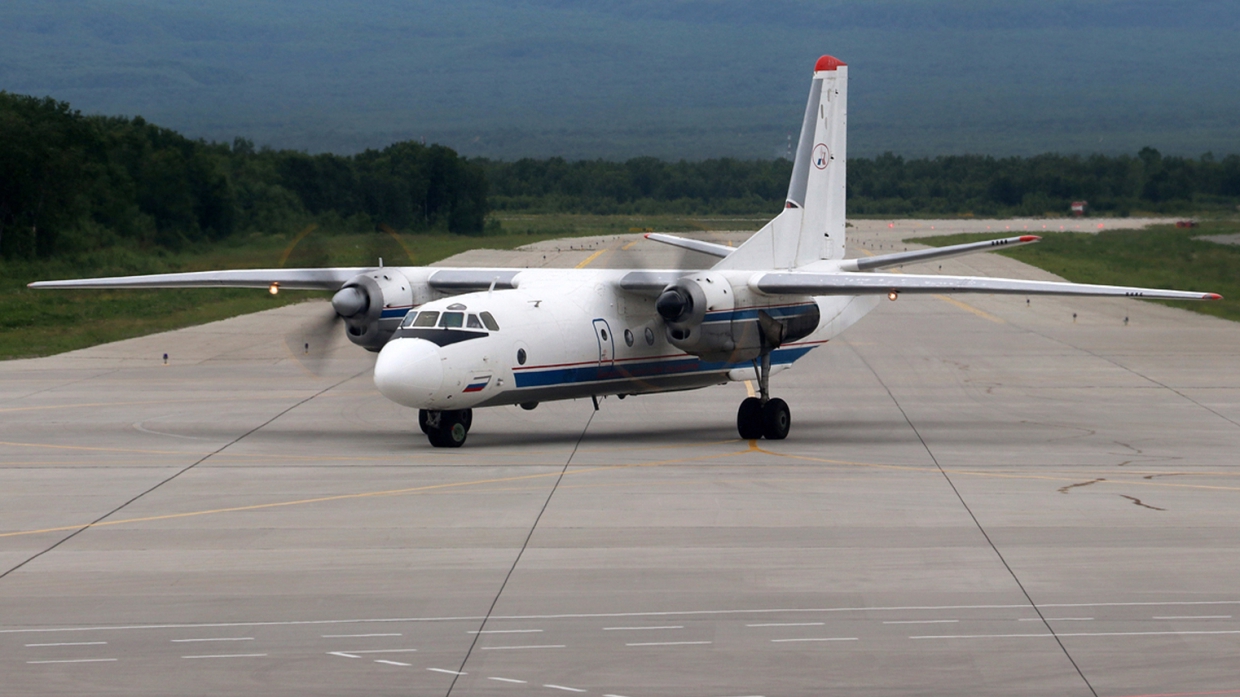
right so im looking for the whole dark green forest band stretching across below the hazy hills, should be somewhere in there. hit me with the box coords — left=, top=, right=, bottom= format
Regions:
left=0, top=92, right=1240, bottom=259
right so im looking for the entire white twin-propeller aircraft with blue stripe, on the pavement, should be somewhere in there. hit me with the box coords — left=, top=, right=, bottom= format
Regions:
left=30, top=56, right=1219, bottom=448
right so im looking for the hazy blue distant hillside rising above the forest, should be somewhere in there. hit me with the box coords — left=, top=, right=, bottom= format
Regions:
left=0, top=0, right=1240, bottom=160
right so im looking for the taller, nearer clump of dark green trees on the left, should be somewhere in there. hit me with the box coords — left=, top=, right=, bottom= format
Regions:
left=0, top=92, right=487, bottom=259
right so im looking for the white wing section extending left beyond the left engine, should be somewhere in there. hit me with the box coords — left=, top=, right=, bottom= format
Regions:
left=27, top=267, right=370, bottom=290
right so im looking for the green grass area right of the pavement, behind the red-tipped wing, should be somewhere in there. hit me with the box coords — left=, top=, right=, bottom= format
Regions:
left=906, top=221, right=1240, bottom=321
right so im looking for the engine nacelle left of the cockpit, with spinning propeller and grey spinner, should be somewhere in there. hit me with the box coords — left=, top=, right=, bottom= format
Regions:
left=331, top=268, right=419, bottom=351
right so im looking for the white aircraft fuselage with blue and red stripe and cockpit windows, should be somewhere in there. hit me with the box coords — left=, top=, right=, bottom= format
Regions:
left=374, top=264, right=878, bottom=409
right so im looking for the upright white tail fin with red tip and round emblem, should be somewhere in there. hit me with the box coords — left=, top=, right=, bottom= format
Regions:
left=715, top=56, right=848, bottom=269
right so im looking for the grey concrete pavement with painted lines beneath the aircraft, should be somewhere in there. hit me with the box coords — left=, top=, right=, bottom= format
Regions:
left=0, top=221, right=1240, bottom=697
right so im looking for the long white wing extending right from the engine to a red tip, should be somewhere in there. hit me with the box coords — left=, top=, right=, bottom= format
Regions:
left=749, top=272, right=1223, bottom=300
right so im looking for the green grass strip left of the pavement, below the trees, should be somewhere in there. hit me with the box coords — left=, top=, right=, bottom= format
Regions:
left=0, top=215, right=760, bottom=358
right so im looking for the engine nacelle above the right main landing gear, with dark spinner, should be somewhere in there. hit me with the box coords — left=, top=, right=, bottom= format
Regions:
left=655, top=272, right=739, bottom=361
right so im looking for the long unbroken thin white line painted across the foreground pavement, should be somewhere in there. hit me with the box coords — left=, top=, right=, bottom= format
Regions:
left=7, top=600, right=1240, bottom=634
